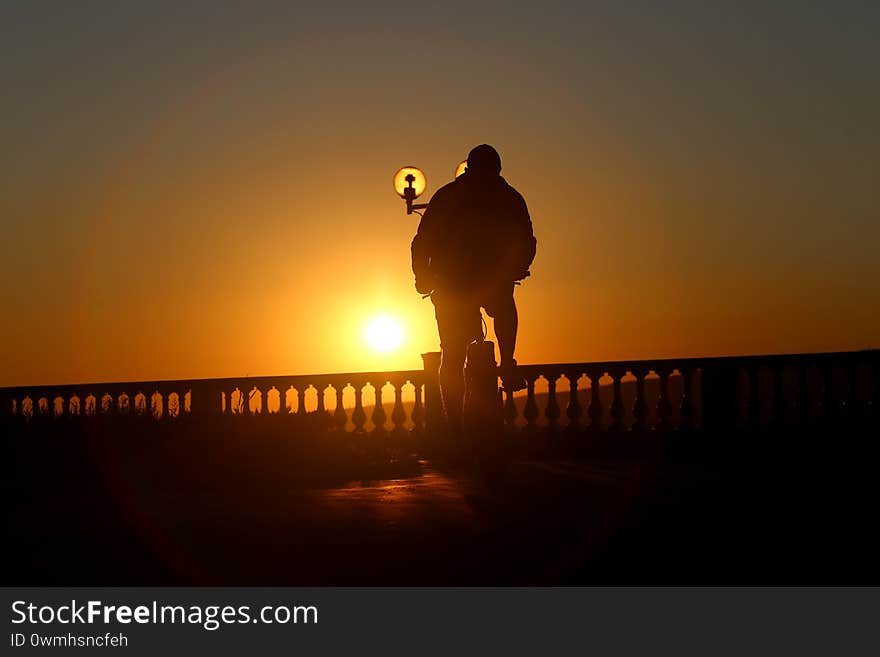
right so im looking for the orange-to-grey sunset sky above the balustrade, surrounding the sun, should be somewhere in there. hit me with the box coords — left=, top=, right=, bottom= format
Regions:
left=0, top=1, right=880, bottom=385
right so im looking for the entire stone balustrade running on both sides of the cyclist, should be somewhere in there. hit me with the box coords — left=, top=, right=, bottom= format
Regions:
left=0, top=351, right=880, bottom=434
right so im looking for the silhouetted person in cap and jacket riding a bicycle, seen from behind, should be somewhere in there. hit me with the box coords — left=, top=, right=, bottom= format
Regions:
left=412, top=144, right=537, bottom=431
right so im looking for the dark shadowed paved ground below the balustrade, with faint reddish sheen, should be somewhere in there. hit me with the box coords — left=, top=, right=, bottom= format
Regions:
left=4, top=426, right=880, bottom=585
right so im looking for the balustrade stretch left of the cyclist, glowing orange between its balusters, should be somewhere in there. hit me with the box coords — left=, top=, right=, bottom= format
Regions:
left=0, top=370, right=425, bottom=433
